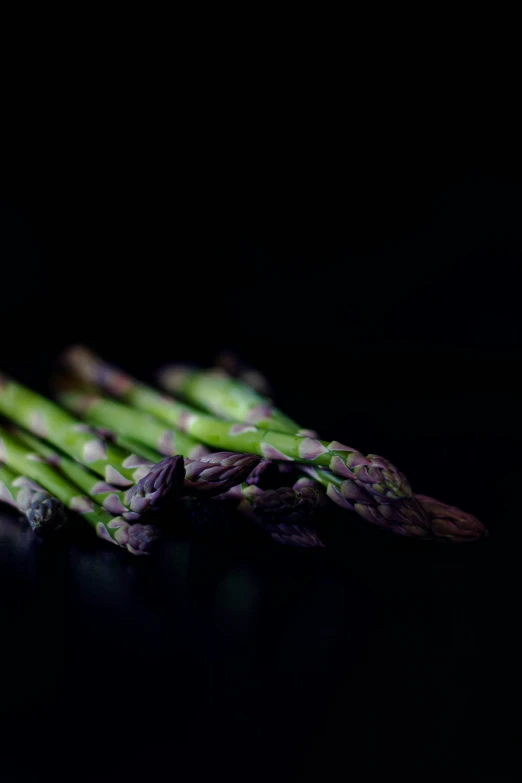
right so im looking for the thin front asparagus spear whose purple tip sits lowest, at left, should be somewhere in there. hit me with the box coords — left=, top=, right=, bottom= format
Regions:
left=0, top=427, right=159, bottom=555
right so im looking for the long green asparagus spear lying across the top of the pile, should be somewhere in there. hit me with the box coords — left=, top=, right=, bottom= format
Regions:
left=60, top=347, right=412, bottom=502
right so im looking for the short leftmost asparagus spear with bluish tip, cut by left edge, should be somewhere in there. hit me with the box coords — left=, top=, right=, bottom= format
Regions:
left=0, top=464, right=67, bottom=538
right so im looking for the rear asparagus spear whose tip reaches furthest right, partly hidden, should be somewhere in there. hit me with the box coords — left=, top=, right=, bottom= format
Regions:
left=161, top=366, right=486, bottom=541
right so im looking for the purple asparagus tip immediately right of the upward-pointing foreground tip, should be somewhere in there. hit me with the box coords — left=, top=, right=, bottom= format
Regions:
left=185, top=451, right=261, bottom=495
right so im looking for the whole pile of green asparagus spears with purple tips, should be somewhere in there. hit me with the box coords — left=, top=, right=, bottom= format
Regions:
left=0, top=346, right=486, bottom=554
